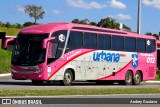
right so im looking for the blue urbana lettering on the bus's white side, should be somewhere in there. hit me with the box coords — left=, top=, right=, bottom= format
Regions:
left=93, top=51, right=120, bottom=62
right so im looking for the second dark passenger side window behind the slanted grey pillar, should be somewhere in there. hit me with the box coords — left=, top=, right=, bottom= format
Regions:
left=84, top=33, right=97, bottom=49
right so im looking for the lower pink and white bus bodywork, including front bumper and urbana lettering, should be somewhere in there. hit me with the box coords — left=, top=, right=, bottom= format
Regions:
left=12, top=49, right=156, bottom=80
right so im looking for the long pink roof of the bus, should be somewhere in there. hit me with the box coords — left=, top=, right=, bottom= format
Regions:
left=20, top=22, right=155, bottom=39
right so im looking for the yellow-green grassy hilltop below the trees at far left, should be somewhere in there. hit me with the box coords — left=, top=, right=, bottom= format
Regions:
left=0, top=27, right=20, bottom=36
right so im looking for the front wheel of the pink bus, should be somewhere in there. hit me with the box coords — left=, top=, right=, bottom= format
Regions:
left=60, top=69, right=73, bottom=86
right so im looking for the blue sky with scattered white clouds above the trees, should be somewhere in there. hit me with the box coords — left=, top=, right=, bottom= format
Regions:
left=0, top=0, right=160, bottom=34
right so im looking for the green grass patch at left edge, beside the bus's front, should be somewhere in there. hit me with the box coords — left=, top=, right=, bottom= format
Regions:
left=0, top=48, right=11, bottom=74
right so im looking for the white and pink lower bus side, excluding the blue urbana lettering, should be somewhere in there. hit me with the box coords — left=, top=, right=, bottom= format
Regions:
left=49, top=50, right=156, bottom=80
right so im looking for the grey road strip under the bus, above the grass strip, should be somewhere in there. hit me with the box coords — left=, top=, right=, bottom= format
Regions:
left=0, top=76, right=160, bottom=90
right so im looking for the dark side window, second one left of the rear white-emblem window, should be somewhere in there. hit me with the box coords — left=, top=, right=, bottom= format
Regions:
left=125, top=37, right=136, bottom=51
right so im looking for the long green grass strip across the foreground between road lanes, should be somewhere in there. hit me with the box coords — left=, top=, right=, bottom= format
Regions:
left=0, top=88, right=160, bottom=96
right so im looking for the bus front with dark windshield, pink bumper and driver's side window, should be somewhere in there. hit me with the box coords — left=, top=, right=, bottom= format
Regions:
left=11, top=31, right=67, bottom=80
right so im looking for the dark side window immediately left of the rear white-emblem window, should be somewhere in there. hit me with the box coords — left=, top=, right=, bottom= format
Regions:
left=137, top=38, right=146, bottom=52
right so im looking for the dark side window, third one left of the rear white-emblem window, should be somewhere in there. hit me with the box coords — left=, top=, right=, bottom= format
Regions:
left=112, top=36, right=124, bottom=50
